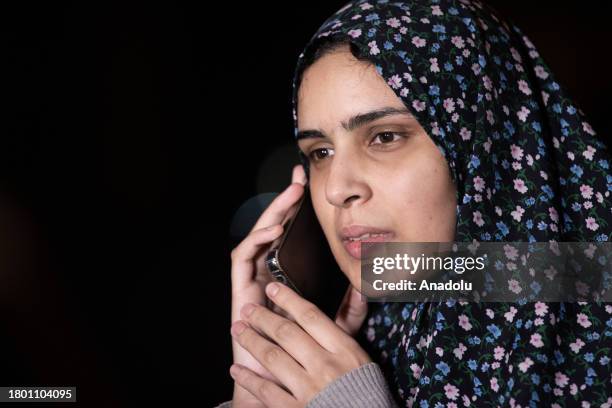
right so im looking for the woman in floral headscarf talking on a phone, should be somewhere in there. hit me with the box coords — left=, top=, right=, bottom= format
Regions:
left=214, top=0, right=612, bottom=407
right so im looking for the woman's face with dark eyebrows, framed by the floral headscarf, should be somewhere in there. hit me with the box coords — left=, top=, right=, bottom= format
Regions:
left=297, top=46, right=456, bottom=289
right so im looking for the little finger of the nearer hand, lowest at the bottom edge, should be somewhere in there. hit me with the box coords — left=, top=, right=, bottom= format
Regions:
left=230, top=364, right=298, bottom=408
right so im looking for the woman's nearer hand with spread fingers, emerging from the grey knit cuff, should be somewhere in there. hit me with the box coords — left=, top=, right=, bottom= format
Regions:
left=230, top=282, right=371, bottom=408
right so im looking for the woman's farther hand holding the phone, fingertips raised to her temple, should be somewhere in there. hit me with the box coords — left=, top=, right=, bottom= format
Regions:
left=231, top=165, right=306, bottom=407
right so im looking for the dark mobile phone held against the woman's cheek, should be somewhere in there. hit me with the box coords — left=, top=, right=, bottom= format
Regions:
left=265, top=184, right=349, bottom=320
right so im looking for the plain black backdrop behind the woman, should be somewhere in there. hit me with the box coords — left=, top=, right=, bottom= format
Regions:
left=0, top=0, right=612, bottom=407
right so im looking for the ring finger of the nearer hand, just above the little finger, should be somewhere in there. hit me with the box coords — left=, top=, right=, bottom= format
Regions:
left=231, top=321, right=309, bottom=398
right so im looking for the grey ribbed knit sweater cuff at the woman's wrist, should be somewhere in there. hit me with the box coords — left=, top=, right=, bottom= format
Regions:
left=214, top=362, right=398, bottom=408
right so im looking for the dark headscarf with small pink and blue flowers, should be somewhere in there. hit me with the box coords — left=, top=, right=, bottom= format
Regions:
left=293, top=0, right=612, bottom=407
